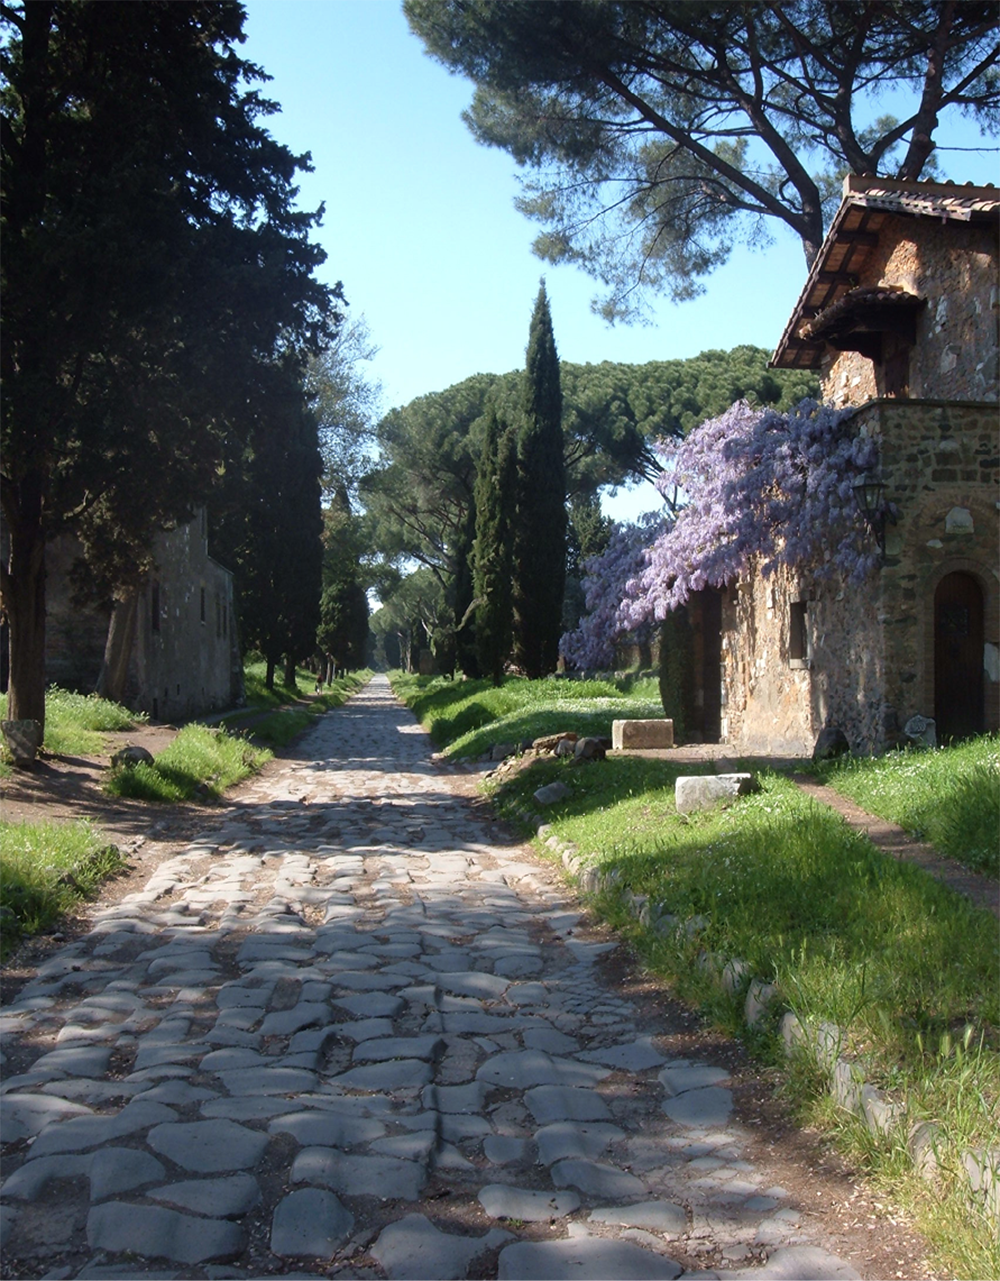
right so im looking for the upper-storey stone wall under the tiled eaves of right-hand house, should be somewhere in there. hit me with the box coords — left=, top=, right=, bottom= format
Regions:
left=823, top=216, right=1000, bottom=405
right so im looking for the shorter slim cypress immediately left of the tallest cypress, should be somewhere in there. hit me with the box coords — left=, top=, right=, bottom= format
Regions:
left=472, top=401, right=517, bottom=685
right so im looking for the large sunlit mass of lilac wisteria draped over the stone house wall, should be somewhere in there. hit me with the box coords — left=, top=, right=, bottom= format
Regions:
left=615, top=401, right=878, bottom=629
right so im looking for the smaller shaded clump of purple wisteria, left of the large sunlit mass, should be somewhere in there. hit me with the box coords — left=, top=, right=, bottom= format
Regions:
left=560, top=512, right=663, bottom=670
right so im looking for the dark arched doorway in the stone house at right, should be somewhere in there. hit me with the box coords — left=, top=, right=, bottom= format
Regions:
left=933, top=573, right=983, bottom=743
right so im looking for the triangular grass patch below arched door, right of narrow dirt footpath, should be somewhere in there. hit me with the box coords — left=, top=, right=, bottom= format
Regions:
left=816, top=734, right=1000, bottom=877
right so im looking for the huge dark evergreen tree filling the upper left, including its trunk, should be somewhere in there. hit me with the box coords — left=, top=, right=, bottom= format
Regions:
left=0, top=0, right=337, bottom=721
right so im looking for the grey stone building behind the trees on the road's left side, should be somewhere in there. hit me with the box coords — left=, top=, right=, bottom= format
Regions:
left=46, top=509, right=243, bottom=721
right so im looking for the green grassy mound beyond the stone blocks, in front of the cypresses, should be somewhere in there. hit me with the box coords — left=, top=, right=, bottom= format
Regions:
left=389, top=671, right=663, bottom=758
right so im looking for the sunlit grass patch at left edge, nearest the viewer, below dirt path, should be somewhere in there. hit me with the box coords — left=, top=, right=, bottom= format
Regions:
left=0, top=821, right=125, bottom=958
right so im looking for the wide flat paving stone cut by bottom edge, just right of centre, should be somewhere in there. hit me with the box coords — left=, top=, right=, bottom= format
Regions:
left=497, top=1236, right=681, bottom=1281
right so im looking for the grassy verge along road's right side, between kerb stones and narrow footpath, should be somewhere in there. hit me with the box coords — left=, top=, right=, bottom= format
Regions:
left=402, top=683, right=1000, bottom=1281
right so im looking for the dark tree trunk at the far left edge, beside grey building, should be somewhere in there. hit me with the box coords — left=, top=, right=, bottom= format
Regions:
left=4, top=503, right=45, bottom=730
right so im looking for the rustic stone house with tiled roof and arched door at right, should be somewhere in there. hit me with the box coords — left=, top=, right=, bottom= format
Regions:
left=689, top=177, right=1000, bottom=753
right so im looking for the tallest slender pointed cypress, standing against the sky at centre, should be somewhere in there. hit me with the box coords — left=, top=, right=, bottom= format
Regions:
left=513, top=283, right=566, bottom=678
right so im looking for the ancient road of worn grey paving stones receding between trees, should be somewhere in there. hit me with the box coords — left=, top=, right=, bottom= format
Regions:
left=0, top=678, right=858, bottom=1281
